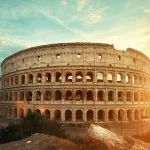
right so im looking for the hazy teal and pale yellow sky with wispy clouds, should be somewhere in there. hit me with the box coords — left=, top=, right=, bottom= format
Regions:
left=0, top=0, right=150, bottom=62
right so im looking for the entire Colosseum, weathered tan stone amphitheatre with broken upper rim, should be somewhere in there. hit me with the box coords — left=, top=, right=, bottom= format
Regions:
left=0, top=43, right=150, bottom=124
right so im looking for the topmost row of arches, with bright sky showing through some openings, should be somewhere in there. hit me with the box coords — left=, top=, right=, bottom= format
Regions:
left=2, top=71, right=147, bottom=87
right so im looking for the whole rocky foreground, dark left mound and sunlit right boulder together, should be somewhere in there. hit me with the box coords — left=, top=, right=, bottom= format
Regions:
left=0, top=124, right=150, bottom=150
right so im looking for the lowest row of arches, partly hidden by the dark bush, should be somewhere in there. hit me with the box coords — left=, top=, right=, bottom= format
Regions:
left=0, top=107, right=149, bottom=122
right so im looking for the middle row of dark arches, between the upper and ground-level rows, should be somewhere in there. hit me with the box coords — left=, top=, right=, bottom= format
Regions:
left=0, top=89, right=150, bottom=101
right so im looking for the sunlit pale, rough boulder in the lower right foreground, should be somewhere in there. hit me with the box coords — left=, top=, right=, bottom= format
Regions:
left=82, top=125, right=150, bottom=150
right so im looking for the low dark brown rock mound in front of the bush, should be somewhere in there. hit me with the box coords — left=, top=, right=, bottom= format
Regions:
left=0, top=134, right=79, bottom=150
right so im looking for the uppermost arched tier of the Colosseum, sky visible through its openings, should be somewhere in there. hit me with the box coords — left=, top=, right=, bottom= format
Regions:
left=2, top=70, right=150, bottom=88
